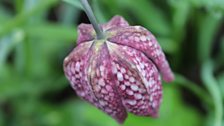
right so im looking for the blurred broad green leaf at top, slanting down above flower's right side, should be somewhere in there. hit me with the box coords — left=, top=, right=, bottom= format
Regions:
left=119, top=0, right=171, bottom=37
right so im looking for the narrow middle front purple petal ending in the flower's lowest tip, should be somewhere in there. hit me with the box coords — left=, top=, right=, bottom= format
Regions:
left=88, top=43, right=127, bottom=123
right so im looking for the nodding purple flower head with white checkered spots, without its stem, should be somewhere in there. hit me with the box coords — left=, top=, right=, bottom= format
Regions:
left=64, top=16, right=174, bottom=123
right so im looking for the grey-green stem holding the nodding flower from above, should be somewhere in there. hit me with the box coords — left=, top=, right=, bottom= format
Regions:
left=80, top=0, right=104, bottom=39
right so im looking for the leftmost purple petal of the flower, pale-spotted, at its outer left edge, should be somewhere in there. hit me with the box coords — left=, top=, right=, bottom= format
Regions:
left=64, top=42, right=96, bottom=103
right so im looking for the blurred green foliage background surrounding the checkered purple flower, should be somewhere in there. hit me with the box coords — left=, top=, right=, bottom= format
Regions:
left=0, top=0, right=224, bottom=126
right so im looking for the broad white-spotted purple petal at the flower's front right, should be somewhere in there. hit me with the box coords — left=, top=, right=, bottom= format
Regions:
left=108, top=42, right=162, bottom=117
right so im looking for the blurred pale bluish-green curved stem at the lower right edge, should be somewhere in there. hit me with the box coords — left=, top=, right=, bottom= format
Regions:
left=201, top=60, right=223, bottom=126
